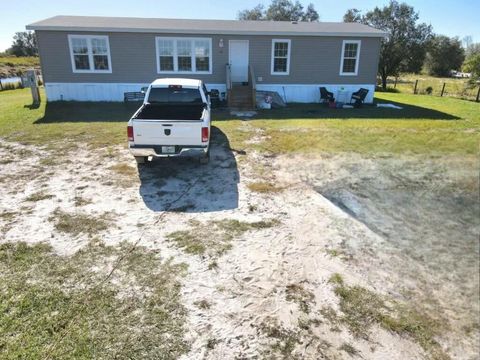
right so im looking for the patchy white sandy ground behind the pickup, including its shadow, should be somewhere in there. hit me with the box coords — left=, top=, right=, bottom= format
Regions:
left=0, top=133, right=480, bottom=359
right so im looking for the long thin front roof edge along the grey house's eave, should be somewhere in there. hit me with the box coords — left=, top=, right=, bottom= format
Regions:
left=25, top=23, right=387, bottom=38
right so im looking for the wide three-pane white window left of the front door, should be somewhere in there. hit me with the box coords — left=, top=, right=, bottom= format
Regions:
left=155, top=37, right=212, bottom=74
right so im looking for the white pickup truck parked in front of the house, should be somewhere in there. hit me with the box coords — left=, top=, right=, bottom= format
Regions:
left=127, top=78, right=210, bottom=163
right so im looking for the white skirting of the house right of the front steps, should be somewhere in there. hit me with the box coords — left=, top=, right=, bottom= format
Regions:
left=257, top=83, right=375, bottom=103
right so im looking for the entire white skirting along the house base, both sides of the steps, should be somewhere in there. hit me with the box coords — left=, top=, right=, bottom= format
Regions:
left=45, top=83, right=375, bottom=103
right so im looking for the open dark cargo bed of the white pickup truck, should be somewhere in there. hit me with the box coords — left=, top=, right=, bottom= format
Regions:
left=133, top=104, right=204, bottom=120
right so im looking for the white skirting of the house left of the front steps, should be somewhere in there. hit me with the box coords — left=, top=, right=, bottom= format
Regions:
left=45, top=83, right=226, bottom=101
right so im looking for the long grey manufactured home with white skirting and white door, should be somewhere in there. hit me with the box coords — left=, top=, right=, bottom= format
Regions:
left=27, top=16, right=385, bottom=102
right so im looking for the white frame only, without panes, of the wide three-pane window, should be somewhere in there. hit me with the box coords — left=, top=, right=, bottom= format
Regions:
left=155, top=36, right=213, bottom=75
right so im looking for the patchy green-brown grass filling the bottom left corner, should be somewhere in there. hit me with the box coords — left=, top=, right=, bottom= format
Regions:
left=0, top=241, right=188, bottom=360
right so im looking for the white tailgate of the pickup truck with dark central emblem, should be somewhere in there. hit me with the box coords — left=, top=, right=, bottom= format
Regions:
left=132, top=119, right=204, bottom=145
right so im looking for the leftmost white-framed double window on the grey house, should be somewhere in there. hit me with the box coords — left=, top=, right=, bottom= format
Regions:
left=68, top=35, right=112, bottom=73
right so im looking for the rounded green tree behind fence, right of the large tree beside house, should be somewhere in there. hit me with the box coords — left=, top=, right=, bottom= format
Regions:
left=425, top=35, right=465, bottom=76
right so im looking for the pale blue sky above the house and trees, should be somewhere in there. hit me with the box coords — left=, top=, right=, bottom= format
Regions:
left=0, top=0, right=480, bottom=51
